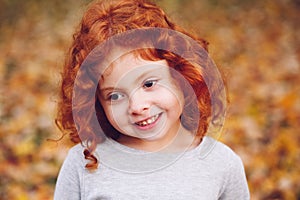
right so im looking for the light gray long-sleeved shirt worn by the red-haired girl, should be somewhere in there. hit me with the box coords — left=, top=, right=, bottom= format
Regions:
left=54, top=137, right=250, bottom=200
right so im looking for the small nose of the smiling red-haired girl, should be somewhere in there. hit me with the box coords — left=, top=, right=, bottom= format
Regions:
left=129, top=90, right=150, bottom=115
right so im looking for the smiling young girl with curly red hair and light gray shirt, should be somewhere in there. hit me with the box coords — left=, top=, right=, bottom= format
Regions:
left=54, top=0, right=249, bottom=200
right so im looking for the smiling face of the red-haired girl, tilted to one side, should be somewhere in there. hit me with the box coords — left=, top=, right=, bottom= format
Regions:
left=98, top=54, right=184, bottom=149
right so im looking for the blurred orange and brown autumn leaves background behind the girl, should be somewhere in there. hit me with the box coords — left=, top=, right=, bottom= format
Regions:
left=0, top=0, right=300, bottom=200
